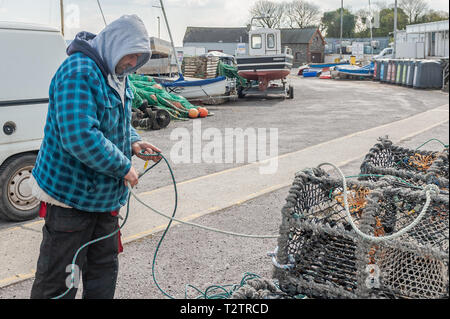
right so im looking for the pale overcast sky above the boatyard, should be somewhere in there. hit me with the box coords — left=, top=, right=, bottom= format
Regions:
left=0, top=0, right=449, bottom=46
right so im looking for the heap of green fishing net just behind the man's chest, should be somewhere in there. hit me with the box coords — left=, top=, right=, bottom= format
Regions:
left=128, top=74, right=203, bottom=121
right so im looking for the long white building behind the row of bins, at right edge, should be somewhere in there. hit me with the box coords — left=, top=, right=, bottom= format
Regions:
left=396, top=20, right=449, bottom=59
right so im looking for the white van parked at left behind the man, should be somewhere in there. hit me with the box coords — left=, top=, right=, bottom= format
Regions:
left=0, top=22, right=66, bottom=221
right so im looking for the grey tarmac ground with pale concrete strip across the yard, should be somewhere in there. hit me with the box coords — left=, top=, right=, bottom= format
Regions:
left=0, top=75, right=449, bottom=299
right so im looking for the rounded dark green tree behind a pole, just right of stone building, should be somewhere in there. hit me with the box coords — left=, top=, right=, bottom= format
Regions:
left=321, top=9, right=356, bottom=38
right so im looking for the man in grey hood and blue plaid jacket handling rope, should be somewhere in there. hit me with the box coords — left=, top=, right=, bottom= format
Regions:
left=30, top=15, right=161, bottom=299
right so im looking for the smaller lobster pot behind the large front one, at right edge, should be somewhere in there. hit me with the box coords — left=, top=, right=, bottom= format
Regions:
left=361, top=138, right=449, bottom=191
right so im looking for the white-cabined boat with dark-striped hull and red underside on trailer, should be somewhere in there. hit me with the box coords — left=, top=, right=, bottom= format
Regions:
left=236, top=28, right=294, bottom=98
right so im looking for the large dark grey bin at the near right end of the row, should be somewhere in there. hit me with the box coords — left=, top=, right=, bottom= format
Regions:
left=413, top=60, right=442, bottom=89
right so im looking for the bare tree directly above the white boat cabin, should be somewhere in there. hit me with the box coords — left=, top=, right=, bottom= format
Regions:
left=250, top=0, right=284, bottom=28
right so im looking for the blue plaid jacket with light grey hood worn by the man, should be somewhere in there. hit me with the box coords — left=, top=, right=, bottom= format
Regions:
left=32, top=16, right=150, bottom=212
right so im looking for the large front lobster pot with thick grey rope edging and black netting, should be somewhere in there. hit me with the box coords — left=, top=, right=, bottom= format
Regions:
left=273, top=169, right=449, bottom=298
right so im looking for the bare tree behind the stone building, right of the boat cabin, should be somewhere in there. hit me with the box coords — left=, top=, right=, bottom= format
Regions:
left=284, top=0, right=320, bottom=28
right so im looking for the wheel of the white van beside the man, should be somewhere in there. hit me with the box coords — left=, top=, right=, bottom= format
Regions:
left=0, top=154, right=40, bottom=221
